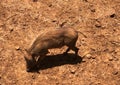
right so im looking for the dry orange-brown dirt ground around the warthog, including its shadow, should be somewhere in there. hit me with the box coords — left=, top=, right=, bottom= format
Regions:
left=0, top=0, right=120, bottom=85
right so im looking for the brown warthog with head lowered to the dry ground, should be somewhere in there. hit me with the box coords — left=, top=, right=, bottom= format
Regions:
left=25, top=28, right=81, bottom=72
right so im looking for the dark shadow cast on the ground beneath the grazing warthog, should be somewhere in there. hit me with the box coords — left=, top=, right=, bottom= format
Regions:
left=34, top=54, right=82, bottom=70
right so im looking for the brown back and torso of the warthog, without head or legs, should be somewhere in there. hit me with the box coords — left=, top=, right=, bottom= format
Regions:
left=29, top=28, right=78, bottom=54
